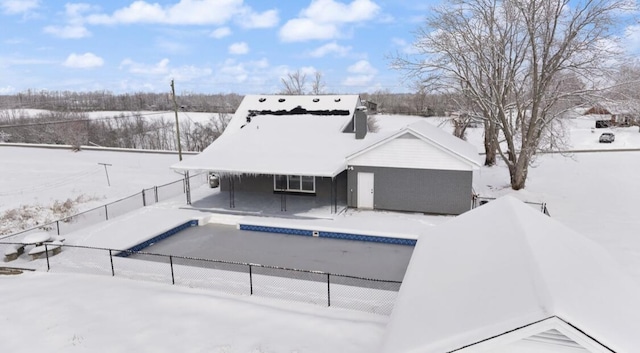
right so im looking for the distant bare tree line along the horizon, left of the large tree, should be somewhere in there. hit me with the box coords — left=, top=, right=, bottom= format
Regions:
left=0, top=88, right=464, bottom=116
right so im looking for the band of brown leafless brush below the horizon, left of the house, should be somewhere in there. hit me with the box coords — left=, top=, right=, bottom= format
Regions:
left=0, top=110, right=231, bottom=151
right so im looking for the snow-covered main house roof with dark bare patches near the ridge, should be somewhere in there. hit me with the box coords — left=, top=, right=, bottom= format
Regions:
left=172, top=95, right=388, bottom=177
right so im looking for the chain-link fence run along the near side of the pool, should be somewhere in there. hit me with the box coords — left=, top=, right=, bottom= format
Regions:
left=0, top=242, right=401, bottom=315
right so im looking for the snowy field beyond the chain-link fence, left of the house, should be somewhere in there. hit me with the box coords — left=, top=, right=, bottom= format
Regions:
left=0, top=146, right=190, bottom=235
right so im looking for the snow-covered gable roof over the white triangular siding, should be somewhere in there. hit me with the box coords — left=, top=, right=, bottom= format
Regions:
left=347, top=120, right=482, bottom=168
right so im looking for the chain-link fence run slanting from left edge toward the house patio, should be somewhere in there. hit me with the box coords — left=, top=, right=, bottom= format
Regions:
left=0, top=173, right=207, bottom=241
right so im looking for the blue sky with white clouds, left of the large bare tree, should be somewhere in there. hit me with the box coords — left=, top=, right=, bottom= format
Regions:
left=0, top=0, right=438, bottom=94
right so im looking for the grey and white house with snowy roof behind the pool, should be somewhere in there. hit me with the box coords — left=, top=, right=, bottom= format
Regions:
left=172, top=95, right=480, bottom=214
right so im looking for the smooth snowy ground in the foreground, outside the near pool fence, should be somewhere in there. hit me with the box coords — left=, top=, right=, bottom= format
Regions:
left=0, top=272, right=385, bottom=353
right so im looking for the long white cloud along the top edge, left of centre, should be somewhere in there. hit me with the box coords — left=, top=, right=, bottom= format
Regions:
left=86, top=0, right=277, bottom=27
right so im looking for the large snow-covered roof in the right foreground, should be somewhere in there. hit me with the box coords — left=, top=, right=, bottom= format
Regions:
left=382, top=196, right=640, bottom=353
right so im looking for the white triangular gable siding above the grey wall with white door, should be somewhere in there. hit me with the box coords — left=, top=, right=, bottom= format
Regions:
left=348, top=133, right=473, bottom=170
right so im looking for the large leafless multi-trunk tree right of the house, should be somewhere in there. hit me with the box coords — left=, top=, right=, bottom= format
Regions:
left=394, top=0, right=629, bottom=190
